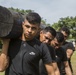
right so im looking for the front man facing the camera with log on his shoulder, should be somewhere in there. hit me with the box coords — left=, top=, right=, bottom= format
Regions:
left=0, top=12, right=55, bottom=75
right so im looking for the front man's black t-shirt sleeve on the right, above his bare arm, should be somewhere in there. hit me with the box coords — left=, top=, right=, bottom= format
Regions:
left=42, top=43, right=52, bottom=64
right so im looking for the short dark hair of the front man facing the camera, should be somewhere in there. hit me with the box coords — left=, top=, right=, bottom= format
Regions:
left=26, top=12, right=41, bottom=25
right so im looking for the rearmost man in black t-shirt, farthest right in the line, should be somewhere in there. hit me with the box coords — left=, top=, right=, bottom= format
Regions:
left=60, top=27, right=75, bottom=73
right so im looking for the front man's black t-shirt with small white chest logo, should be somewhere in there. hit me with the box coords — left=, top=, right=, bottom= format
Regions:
left=5, top=39, right=52, bottom=75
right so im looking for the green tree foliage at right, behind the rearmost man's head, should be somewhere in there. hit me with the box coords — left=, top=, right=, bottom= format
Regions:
left=52, top=16, right=76, bottom=39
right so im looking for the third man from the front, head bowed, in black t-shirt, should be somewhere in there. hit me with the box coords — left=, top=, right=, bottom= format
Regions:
left=50, top=32, right=72, bottom=75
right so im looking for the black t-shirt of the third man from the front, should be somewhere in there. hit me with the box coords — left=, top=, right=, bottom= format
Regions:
left=55, top=47, right=67, bottom=73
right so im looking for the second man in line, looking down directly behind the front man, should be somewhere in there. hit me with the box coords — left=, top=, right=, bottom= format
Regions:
left=39, top=26, right=60, bottom=75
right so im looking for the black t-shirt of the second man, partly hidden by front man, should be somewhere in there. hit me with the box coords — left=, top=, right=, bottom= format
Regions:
left=39, top=45, right=56, bottom=75
